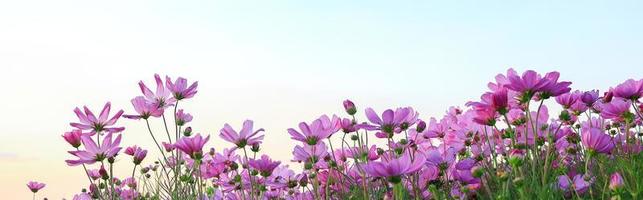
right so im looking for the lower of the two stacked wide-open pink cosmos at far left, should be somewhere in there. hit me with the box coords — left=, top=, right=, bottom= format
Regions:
left=65, top=133, right=121, bottom=166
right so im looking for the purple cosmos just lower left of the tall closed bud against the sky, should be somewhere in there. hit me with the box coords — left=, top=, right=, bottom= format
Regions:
left=288, top=115, right=341, bottom=145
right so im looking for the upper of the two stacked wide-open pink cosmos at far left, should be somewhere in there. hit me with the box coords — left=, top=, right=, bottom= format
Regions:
left=69, top=102, right=125, bottom=133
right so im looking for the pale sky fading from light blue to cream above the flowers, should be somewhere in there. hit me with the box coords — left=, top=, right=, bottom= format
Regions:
left=0, top=0, right=643, bottom=199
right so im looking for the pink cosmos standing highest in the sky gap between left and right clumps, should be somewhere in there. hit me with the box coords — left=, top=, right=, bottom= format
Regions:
left=219, top=120, right=264, bottom=148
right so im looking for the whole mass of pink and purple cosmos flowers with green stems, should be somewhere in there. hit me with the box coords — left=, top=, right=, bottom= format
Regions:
left=28, top=69, right=643, bottom=200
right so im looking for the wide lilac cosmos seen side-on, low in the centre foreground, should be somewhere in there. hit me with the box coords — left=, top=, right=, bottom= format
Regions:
left=364, top=153, right=426, bottom=183
